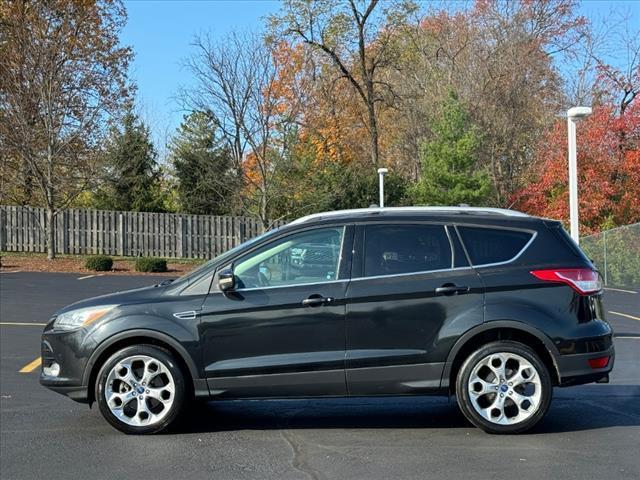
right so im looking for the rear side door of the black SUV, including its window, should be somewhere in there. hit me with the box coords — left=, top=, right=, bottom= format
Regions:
left=346, top=223, right=483, bottom=395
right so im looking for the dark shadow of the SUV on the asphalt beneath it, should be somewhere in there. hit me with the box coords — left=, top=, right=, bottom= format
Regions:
left=173, top=385, right=640, bottom=434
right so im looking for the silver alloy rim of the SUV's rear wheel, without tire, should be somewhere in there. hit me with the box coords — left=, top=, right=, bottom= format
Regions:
left=467, top=352, right=542, bottom=425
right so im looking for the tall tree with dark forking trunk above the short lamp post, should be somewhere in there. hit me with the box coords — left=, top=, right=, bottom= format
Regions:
left=271, top=0, right=416, bottom=167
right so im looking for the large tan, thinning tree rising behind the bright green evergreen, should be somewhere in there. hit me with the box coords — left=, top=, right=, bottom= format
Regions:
left=390, top=0, right=584, bottom=207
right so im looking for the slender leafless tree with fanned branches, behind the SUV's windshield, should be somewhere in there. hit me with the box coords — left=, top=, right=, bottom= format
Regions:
left=180, top=33, right=295, bottom=228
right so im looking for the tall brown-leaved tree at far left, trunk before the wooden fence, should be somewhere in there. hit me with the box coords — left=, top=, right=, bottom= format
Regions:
left=0, top=0, right=131, bottom=259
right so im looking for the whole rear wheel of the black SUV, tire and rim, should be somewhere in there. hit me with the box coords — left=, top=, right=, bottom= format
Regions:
left=456, top=340, right=553, bottom=434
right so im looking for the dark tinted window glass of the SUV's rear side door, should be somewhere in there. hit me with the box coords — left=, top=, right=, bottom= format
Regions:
left=364, top=225, right=451, bottom=277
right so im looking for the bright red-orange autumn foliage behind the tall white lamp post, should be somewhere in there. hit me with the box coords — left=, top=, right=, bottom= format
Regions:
left=512, top=104, right=640, bottom=234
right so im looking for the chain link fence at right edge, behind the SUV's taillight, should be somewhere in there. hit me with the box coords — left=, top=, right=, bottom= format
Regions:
left=580, top=223, right=640, bottom=288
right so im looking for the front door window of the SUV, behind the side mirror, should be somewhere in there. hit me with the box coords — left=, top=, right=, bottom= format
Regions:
left=233, top=227, right=344, bottom=288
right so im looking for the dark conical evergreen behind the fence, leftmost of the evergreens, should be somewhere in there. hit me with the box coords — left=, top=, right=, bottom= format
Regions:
left=95, top=110, right=164, bottom=212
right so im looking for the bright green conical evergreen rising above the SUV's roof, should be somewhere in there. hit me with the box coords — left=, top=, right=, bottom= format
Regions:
left=411, top=92, right=491, bottom=205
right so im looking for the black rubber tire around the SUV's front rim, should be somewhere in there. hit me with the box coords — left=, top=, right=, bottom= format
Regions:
left=95, top=345, right=186, bottom=435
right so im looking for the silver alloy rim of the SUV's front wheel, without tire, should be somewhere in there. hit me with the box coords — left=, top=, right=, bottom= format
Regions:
left=104, top=355, right=175, bottom=427
